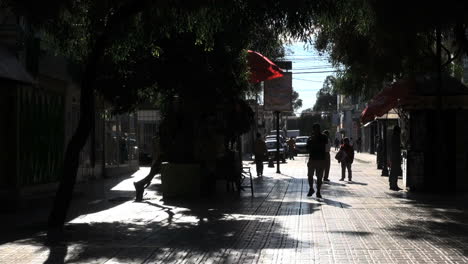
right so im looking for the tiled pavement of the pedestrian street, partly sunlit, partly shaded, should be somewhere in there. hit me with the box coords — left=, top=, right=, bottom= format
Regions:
left=0, top=154, right=468, bottom=263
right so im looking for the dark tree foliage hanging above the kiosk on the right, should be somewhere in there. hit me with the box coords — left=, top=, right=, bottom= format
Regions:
left=308, top=0, right=468, bottom=97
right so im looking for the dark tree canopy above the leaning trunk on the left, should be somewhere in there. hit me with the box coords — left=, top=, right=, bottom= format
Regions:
left=10, top=0, right=340, bottom=142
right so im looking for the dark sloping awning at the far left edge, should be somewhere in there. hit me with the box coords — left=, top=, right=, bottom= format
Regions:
left=0, top=46, right=34, bottom=84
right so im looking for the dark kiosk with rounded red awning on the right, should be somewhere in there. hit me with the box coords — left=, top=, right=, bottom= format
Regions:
left=361, top=76, right=468, bottom=193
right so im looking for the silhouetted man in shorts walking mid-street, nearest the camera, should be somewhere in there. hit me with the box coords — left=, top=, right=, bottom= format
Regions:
left=307, top=123, right=328, bottom=198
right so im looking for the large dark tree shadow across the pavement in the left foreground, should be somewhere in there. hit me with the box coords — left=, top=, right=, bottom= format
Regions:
left=12, top=213, right=308, bottom=263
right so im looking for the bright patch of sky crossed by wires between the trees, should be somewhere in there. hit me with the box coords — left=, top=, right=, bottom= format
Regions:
left=285, top=42, right=335, bottom=114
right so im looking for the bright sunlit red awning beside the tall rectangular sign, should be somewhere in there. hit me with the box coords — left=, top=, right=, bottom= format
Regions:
left=247, top=50, right=283, bottom=83
